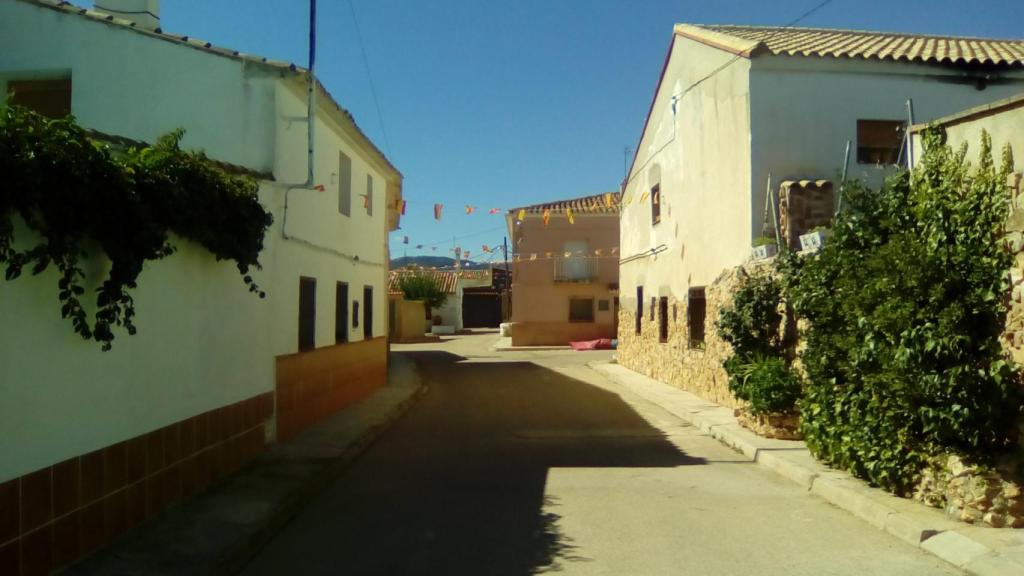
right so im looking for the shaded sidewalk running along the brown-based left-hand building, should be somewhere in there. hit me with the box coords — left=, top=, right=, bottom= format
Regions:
left=65, top=354, right=425, bottom=576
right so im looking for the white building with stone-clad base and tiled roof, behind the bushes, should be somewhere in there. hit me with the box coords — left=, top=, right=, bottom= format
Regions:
left=618, top=25, right=1024, bottom=397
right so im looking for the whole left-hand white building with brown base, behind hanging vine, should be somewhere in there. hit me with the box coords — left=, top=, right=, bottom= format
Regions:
left=0, top=0, right=401, bottom=572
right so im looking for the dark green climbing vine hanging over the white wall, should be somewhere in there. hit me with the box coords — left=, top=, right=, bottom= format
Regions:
left=0, top=106, right=272, bottom=351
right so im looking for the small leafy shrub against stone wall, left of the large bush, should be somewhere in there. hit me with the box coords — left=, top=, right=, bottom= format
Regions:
left=716, top=276, right=801, bottom=415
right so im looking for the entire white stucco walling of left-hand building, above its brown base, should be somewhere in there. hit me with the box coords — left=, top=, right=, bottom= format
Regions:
left=0, top=1, right=395, bottom=482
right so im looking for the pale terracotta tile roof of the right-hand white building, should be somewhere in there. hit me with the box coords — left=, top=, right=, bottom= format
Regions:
left=676, top=25, right=1024, bottom=67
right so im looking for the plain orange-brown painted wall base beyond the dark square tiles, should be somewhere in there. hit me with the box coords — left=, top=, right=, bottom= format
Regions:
left=278, top=337, right=387, bottom=440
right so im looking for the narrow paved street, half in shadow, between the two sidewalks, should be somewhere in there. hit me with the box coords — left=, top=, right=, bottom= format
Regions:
left=245, top=333, right=957, bottom=576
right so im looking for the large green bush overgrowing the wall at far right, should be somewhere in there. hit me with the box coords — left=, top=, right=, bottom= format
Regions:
left=780, top=132, right=1021, bottom=494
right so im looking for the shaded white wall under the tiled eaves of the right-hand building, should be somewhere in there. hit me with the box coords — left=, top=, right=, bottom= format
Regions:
left=750, top=55, right=1024, bottom=239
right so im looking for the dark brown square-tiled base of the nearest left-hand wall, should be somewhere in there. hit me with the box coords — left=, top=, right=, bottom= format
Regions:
left=0, top=393, right=273, bottom=576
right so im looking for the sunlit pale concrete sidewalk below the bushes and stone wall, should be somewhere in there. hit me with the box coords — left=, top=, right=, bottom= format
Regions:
left=589, top=362, right=1024, bottom=576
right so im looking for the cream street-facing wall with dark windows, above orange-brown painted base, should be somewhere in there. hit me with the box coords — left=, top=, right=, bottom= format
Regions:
left=273, top=81, right=388, bottom=355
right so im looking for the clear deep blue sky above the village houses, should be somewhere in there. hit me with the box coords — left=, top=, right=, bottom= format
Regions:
left=151, top=0, right=1024, bottom=259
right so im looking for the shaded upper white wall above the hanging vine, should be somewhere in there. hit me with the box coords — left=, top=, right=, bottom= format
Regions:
left=0, top=0, right=280, bottom=171
